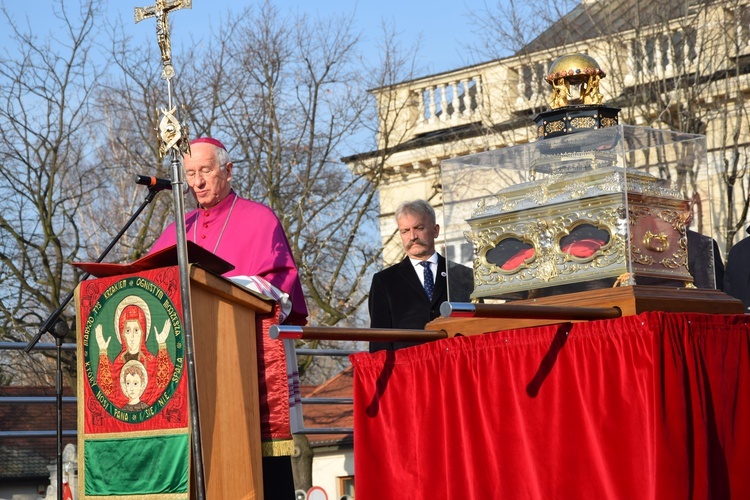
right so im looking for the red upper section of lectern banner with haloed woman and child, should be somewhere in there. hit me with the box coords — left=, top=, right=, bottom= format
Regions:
left=78, top=267, right=188, bottom=435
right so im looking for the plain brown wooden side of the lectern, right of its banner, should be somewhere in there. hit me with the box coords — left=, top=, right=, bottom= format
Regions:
left=190, top=267, right=272, bottom=499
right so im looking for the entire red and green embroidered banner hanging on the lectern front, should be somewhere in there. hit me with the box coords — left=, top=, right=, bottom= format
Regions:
left=76, top=267, right=190, bottom=500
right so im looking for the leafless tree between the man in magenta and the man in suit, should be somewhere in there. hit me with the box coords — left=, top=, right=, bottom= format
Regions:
left=175, top=3, right=376, bottom=325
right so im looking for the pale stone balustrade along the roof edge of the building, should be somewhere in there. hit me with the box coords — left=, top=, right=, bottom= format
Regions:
left=376, top=8, right=750, bottom=147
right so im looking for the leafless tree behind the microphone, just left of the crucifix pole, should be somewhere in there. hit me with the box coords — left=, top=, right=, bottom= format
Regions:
left=85, top=16, right=172, bottom=261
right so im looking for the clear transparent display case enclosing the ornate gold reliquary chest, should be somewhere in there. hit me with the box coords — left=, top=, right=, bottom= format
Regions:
left=441, top=124, right=716, bottom=300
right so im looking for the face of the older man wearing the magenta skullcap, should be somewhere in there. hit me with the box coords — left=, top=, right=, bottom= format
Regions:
left=183, top=143, right=233, bottom=208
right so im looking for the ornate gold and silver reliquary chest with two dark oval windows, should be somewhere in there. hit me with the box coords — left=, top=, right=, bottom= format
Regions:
left=465, top=162, right=692, bottom=297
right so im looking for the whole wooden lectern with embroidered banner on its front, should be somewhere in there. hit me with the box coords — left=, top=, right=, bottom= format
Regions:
left=75, top=242, right=273, bottom=499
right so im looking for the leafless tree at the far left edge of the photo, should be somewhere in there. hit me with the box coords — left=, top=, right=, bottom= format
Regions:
left=0, top=1, right=103, bottom=383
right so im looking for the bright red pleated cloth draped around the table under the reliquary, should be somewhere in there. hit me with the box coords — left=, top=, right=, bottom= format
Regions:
left=351, top=313, right=750, bottom=500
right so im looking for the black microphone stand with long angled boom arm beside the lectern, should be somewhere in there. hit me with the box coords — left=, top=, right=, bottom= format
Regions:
left=24, top=185, right=165, bottom=500
